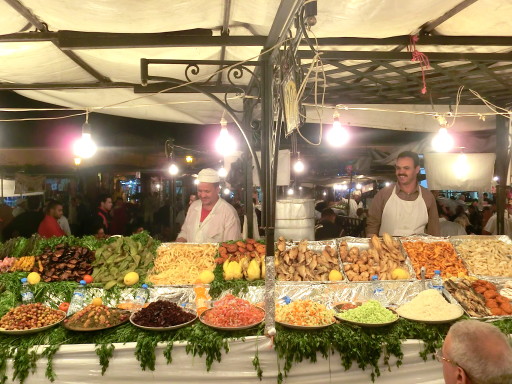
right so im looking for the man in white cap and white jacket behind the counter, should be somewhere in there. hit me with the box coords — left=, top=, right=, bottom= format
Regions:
left=176, top=168, right=242, bottom=243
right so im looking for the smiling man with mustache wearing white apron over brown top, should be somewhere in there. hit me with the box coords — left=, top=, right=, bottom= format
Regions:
left=366, top=151, right=440, bottom=236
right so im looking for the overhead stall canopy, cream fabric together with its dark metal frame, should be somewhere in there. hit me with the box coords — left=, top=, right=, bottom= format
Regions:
left=0, top=0, right=512, bottom=131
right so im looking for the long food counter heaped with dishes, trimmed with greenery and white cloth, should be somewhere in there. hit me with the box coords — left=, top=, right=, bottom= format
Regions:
left=0, top=233, right=512, bottom=383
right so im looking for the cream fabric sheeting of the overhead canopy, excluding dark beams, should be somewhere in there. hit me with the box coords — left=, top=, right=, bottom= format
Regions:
left=0, top=0, right=512, bottom=131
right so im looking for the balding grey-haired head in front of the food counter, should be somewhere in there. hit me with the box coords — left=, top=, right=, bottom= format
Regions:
left=443, top=320, right=512, bottom=384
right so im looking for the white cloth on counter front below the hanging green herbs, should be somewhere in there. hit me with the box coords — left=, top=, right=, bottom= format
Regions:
left=8, top=337, right=444, bottom=384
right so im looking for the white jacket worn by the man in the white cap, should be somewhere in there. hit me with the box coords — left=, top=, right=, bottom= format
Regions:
left=178, top=198, right=242, bottom=243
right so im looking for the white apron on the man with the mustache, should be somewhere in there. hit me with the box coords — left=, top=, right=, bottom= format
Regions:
left=379, top=186, right=428, bottom=236
